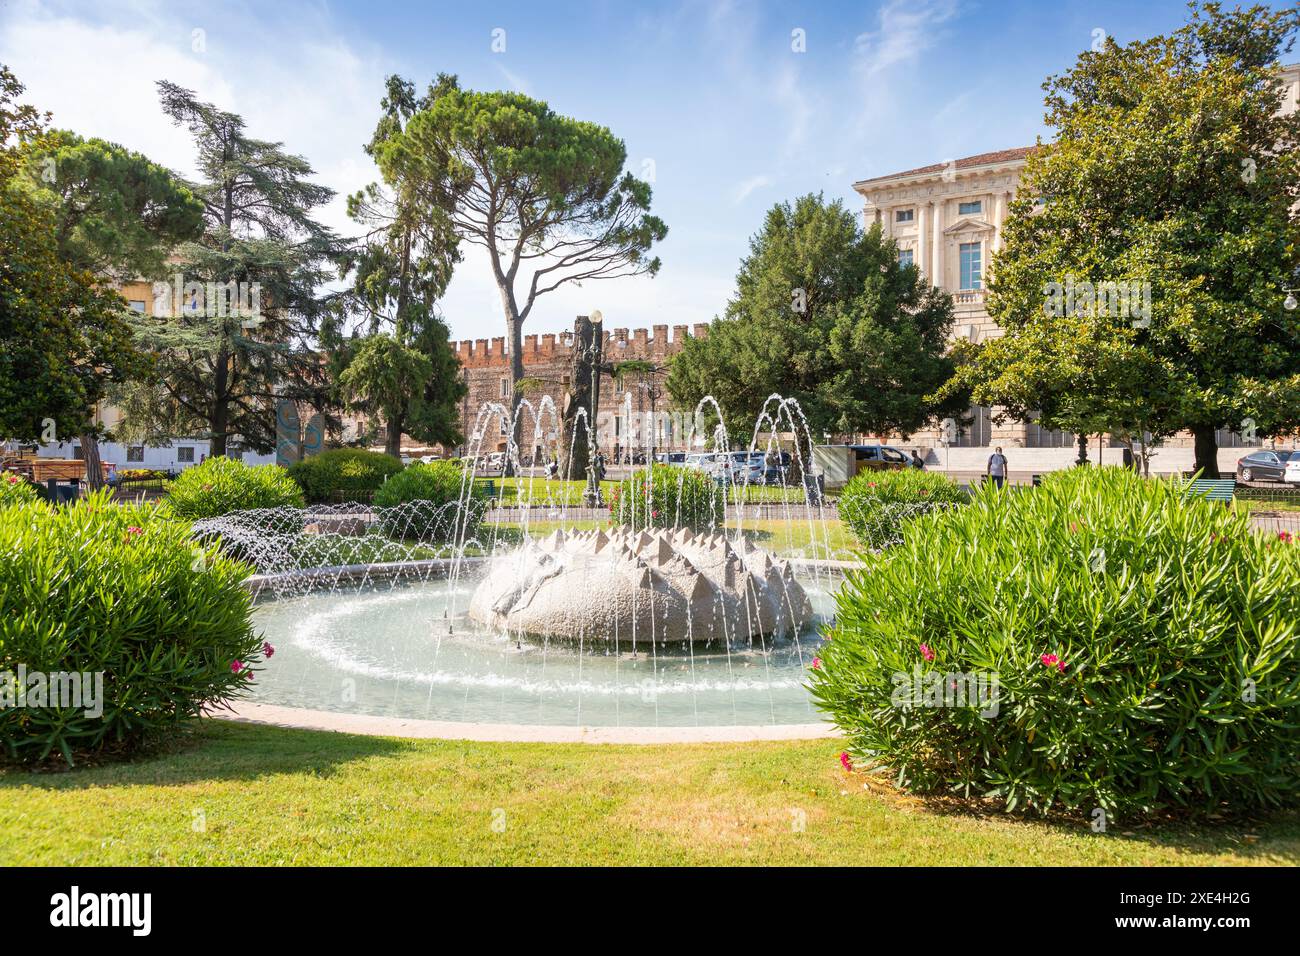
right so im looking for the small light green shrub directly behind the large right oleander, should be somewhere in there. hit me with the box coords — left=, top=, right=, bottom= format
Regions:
left=840, top=468, right=970, bottom=550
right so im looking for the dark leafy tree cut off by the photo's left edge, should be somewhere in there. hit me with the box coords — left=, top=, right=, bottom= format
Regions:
left=0, top=64, right=140, bottom=455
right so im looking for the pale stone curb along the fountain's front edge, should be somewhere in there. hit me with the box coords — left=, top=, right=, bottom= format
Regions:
left=211, top=701, right=840, bottom=744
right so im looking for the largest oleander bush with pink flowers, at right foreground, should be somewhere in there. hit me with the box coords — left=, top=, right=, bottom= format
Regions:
left=813, top=468, right=1300, bottom=818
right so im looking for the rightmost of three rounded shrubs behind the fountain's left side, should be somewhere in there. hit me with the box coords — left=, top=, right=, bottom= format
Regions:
left=374, top=462, right=486, bottom=541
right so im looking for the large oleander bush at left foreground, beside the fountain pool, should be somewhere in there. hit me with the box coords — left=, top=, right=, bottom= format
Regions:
left=0, top=492, right=264, bottom=762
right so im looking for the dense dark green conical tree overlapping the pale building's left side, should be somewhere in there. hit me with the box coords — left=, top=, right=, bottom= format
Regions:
left=667, top=195, right=956, bottom=447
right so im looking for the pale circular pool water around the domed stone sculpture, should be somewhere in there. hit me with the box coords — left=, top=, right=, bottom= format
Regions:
left=245, top=571, right=833, bottom=727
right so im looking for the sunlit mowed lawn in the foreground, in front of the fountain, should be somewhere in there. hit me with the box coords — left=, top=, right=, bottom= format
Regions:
left=0, top=722, right=1300, bottom=865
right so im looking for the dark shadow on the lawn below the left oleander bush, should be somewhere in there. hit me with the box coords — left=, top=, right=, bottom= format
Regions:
left=0, top=717, right=424, bottom=800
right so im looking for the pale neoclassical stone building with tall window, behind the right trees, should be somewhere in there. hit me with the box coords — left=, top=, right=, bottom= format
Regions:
left=853, top=64, right=1300, bottom=467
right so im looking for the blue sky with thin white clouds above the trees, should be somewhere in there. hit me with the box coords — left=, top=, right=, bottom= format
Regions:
left=0, top=0, right=1279, bottom=338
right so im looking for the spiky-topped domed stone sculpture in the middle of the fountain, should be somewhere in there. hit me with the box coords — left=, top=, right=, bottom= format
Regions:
left=469, top=528, right=813, bottom=645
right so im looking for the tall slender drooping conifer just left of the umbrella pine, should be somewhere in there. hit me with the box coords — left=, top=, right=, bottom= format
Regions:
left=335, top=75, right=465, bottom=457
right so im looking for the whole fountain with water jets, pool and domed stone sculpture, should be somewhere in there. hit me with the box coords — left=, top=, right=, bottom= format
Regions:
left=195, top=397, right=849, bottom=727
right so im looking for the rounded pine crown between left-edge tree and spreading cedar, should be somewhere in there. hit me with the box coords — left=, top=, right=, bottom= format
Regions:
left=22, top=130, right=203, bottom=488
